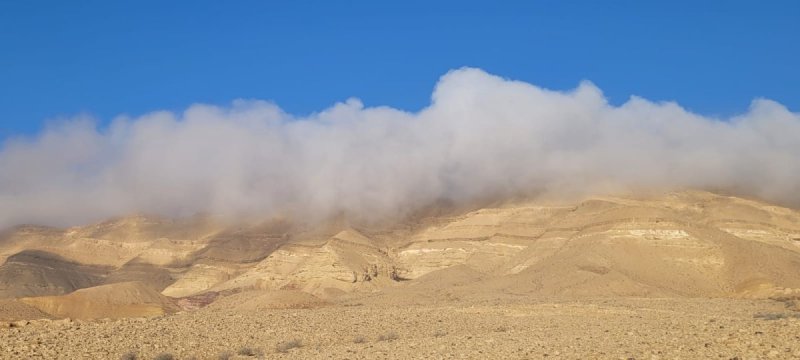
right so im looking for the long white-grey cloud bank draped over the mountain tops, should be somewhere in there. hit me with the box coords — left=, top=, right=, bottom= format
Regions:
left=0, top=68, right=800, bottom=228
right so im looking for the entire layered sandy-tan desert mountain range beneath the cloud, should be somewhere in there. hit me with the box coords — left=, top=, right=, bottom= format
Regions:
left=0, top=191, right=800, bottom=317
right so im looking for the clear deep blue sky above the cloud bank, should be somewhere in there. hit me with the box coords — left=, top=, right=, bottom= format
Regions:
left=0, top=0, right=800, bottom=139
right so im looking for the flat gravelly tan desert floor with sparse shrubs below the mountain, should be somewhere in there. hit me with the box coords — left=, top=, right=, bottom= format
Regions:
left=0, top=298, right=800, bottom=359
